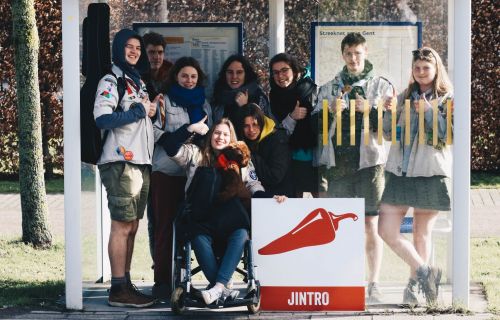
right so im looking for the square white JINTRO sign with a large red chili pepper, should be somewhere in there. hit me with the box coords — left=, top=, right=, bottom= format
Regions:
left=252, top=198, right=365, bottom=311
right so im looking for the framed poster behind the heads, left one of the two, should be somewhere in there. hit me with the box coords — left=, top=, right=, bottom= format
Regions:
left=134, top=22, right=243, bottom=98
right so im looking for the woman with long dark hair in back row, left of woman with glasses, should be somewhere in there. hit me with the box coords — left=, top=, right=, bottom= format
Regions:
left=211, top=54, right=273, bottom=124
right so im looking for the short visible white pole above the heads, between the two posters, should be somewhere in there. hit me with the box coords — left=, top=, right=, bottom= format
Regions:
left=269, top=0, right=285, bottom=58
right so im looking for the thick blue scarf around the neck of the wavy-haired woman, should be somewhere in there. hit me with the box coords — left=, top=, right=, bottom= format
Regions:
left=167, top=83, right=205, bottom=123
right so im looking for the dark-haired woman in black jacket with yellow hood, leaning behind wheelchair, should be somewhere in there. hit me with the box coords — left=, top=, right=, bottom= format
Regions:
left=236, top=103, right=294, bottom=197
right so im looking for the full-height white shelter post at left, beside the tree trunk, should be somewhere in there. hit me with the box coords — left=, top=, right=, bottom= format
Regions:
left=62, top=0, right=83, bottom=310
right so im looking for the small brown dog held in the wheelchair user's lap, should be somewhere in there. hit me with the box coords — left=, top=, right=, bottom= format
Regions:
left=216, top=141, right=252, bottom=212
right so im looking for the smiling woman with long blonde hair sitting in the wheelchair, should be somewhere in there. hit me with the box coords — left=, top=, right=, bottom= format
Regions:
left=166, top=117, right=286, bottom=305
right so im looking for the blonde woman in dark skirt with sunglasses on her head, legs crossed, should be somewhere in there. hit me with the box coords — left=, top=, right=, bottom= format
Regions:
left=378, top=47, right=453, bottom=305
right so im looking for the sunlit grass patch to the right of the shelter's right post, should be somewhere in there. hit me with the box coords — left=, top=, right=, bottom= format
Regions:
left=471, top=237, right=500, bottom=315
